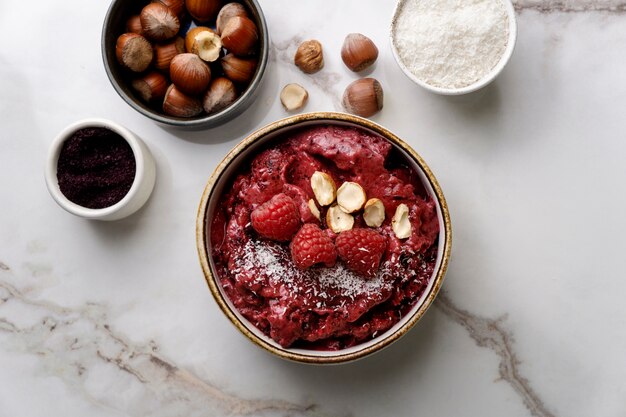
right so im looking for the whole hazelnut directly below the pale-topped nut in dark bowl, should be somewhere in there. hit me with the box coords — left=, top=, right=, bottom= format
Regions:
left=170, top=53, right=211, bottom=95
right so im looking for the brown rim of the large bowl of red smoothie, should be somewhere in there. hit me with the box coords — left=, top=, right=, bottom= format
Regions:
left=196, top=112, right=452, bottom=365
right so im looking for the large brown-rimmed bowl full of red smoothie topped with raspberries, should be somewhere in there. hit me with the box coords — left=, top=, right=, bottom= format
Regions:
left=196, top=113, right=451, bottom=364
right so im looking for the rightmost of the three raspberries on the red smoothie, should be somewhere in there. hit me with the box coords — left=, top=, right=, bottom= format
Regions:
left=335, top=228, right=387, bottom=278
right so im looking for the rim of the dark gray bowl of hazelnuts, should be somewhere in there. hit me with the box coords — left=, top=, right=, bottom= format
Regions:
left=100, top=0, right=270, bottom=129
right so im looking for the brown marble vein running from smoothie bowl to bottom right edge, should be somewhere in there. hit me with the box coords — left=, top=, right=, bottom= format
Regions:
left=435, top=291, right=557, bottom=417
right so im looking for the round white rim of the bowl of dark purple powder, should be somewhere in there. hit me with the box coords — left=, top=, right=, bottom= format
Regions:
left=44, top=117, right=146, bottom=220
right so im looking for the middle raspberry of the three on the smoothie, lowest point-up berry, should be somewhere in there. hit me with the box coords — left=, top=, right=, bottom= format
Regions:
left=291, top=223, right=337, bottom=269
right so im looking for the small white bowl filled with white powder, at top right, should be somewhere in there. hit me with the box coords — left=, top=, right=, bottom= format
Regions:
left=391, top=0, right=517, bottom=94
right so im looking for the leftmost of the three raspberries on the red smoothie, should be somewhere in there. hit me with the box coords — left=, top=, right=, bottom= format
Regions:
left=250, top=193, right=300, bottom=242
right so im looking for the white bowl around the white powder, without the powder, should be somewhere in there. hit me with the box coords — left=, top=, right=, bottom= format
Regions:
left=389, top=0, right=517, bottom=96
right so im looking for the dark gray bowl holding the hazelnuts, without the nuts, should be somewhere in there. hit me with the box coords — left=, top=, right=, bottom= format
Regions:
left=102, top=0, right=269, bottom=129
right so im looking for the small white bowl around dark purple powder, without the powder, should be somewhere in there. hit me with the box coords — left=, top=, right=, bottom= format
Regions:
left=45, top=118, right=156, bottom=220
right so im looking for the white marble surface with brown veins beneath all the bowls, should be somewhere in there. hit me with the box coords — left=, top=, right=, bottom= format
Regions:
left=0, top=0, right=626, bottom=417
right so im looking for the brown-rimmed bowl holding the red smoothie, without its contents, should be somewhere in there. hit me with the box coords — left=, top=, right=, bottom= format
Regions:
left=196, top=112, right=452, bottom=364
